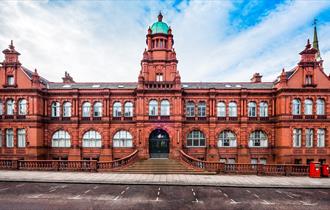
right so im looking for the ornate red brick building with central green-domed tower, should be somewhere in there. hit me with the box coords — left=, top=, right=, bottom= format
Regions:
left=0, top=14, right=330, bottom=163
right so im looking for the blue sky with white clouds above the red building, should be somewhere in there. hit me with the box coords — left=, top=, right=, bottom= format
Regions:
left=0, top=0, right=330, bottom=82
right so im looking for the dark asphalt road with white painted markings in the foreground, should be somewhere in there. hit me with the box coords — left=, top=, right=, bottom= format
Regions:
left=0, top=182, right=330, bottom=210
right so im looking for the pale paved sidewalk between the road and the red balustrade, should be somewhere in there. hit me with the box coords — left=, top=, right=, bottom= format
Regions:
left=0, top=171, right=330, bottom=189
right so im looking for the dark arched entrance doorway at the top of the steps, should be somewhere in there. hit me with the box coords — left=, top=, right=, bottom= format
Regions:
left=149, top=129, right=170, bottom=158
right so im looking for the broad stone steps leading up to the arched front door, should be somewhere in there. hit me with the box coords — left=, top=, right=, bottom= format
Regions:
left=118, top=158, right=215, bottom=174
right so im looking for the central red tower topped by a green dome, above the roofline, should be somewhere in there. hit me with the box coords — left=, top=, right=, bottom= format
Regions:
left=139, top=13, right=181, bottom=88
